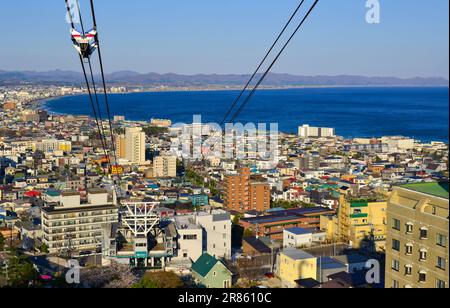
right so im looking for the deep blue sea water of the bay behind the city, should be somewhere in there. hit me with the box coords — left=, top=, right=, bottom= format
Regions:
left=45, top=87, right=449, bottom=142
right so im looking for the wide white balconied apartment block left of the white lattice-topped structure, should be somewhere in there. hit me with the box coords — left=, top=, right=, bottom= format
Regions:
left=41, top=189, right=119, bottom=253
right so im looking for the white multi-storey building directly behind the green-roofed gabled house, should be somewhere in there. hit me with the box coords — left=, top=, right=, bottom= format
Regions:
left=196, top=210, right=232, bottom=259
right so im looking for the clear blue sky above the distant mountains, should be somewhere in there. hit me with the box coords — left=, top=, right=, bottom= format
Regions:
left=0, top=0, right=449, bottom=78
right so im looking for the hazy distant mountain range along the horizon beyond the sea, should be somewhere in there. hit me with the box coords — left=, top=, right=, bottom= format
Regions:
left=0, top=70, right=449, bottom=87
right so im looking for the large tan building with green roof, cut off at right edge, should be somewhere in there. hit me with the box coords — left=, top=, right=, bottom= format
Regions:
left=385, top=182, right=449, bottom=288
